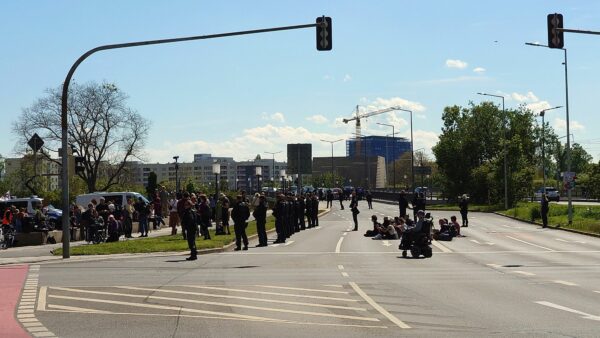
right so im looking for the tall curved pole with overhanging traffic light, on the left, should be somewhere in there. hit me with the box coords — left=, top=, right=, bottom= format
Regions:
left=61, top=16, right=331, bottom=258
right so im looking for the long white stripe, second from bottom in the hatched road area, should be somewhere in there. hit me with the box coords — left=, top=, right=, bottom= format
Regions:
left=49, top=287, right=379, bottom=322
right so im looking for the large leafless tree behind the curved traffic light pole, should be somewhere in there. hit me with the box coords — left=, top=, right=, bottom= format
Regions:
left=13, top=82, right=150, bottom=192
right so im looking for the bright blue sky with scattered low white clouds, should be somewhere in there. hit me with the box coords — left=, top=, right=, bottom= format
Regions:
left=0, top=0, right=600, bottom=162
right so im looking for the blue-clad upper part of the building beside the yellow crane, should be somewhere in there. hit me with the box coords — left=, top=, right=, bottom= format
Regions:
left=346, top=136, right=411, bottom=163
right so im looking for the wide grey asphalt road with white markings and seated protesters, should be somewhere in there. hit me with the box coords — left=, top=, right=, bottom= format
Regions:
left=12, top=202, right=600, bottom=338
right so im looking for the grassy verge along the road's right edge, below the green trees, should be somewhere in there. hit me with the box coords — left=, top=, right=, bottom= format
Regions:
left=500, top=202, right=600, bottom=234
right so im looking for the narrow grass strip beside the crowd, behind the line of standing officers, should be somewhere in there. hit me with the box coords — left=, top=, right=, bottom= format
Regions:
left=53, top=216, right=275, bottom=256
